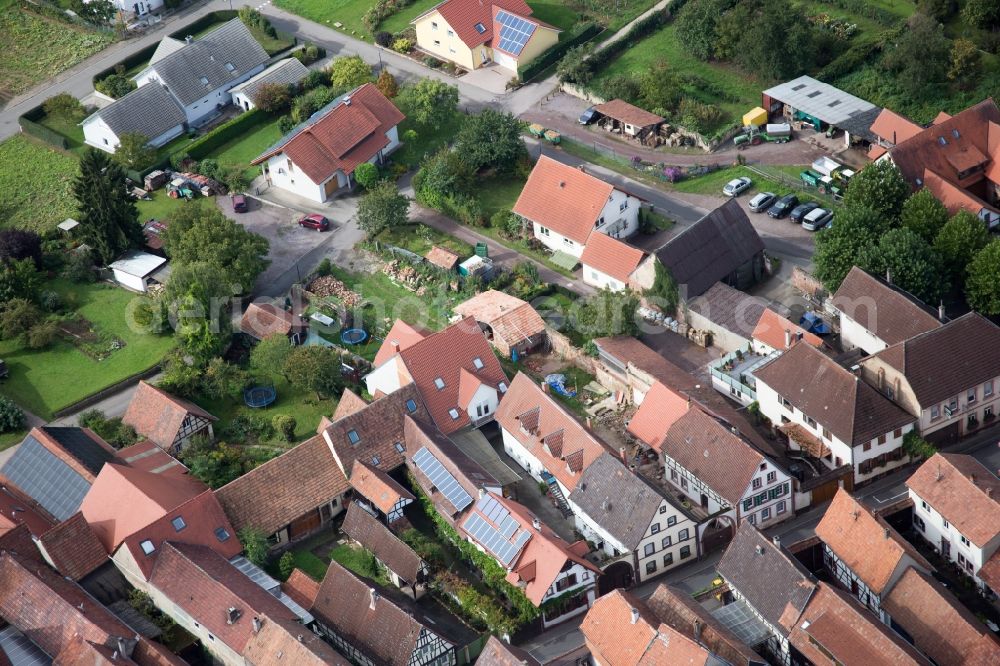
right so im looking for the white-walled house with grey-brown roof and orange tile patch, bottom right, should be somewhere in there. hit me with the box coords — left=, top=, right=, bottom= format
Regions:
left=716, top=522, right=816, bottom=664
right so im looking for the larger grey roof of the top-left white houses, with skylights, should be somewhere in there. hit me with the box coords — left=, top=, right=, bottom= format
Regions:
left=143, top=18, right=268, bottom=105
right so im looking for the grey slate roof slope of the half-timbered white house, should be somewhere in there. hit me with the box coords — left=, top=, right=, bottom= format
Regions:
left=569, top=453, right=680, bottom=550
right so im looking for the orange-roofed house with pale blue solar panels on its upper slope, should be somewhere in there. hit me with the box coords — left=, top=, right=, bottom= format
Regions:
left=459, top=493, right=601, bottom=627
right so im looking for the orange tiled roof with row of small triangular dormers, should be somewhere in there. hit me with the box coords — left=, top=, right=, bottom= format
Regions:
left=496, top=373, right=614, bottom=491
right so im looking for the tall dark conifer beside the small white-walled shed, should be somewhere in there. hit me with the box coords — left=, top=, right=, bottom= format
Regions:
left=73, top=148, right=143, bottom=265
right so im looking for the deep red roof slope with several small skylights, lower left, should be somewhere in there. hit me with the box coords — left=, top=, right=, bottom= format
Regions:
left=122, top=490, right=243, bottom=578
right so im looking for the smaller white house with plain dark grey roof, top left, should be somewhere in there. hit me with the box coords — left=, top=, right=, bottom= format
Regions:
left=80, top=84, right=187, bottom=153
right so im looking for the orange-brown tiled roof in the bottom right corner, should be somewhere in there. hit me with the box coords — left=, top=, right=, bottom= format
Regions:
left=882, top=569, right=1000, bottom=664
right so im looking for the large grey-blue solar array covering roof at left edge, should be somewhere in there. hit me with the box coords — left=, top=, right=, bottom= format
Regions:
left=0, top=435, right=90, bottom=521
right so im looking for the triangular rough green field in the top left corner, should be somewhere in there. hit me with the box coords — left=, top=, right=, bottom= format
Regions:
left=0, top=0, right=113, bottom=105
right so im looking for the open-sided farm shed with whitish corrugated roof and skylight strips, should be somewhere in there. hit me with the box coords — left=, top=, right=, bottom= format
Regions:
left=761, top=76, right=882, bottom=147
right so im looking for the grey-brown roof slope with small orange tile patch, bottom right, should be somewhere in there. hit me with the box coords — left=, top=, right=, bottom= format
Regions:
left=716, top=521, right=816, bottom=636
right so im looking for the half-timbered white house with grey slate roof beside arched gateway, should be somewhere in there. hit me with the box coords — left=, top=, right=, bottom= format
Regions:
left=569, top=453, right=699, bottom=585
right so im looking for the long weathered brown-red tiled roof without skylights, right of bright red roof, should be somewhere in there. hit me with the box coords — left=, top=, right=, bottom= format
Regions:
left=215, top=435, right=348, bottom=534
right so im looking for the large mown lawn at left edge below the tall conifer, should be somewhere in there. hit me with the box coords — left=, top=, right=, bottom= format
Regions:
left=0, top=279, right=173, bottom=420
